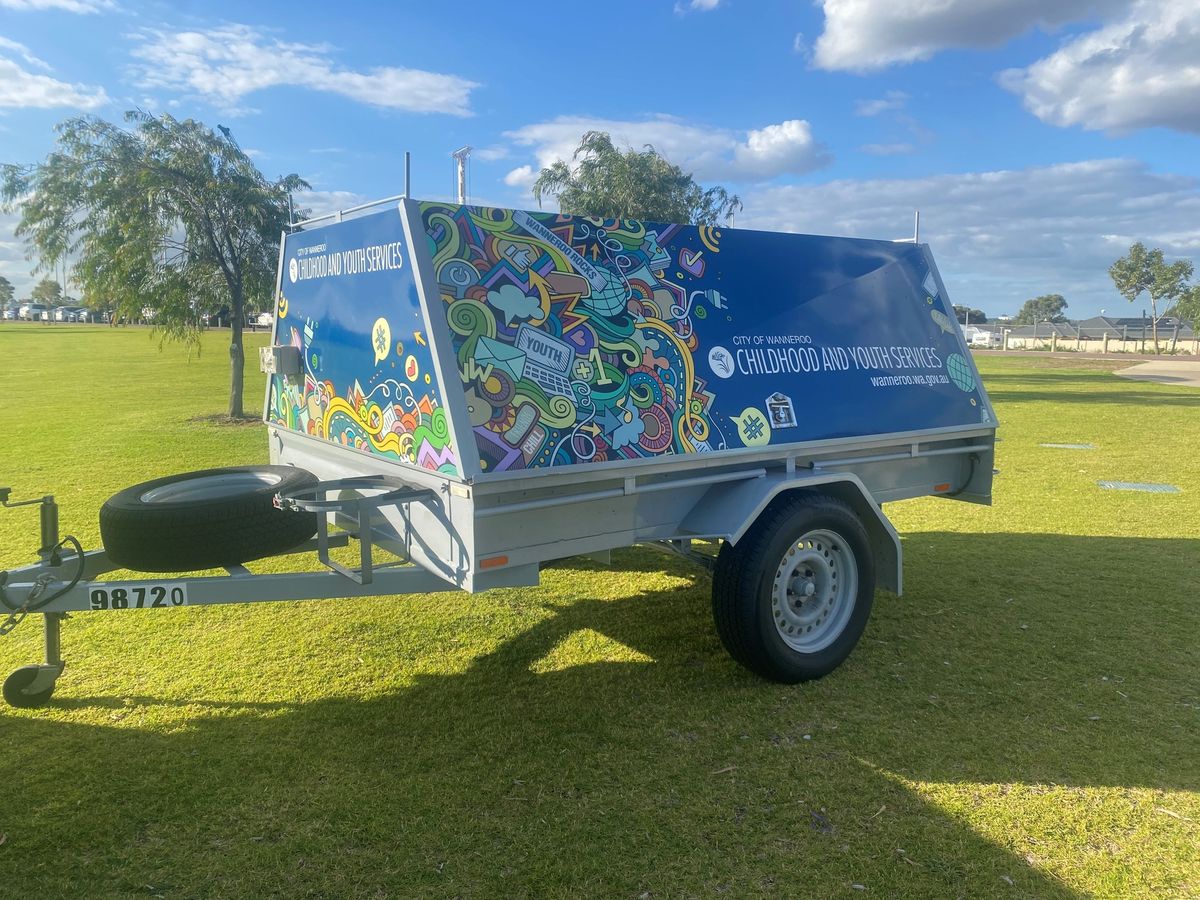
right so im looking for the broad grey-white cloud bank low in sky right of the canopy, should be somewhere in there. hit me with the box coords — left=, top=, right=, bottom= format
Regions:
left=738, top=160, right=1200, bottom=316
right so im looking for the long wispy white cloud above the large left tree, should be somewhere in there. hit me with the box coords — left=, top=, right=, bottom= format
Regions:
left=133, top=25, right=479, bottom=115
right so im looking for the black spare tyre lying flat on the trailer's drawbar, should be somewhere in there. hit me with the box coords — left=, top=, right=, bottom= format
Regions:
left=100, top=466, right=317, bottom=572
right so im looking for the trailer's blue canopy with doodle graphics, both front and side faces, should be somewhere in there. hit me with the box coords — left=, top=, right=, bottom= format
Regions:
left=266, top=203, right=989, bottom=478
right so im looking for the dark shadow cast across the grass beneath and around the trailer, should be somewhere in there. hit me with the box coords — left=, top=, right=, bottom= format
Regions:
left=0, top=533, right=1200, bottom=896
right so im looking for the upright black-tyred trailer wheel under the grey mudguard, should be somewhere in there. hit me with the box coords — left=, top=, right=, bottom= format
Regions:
left=713, top=494, right=875, bottom=684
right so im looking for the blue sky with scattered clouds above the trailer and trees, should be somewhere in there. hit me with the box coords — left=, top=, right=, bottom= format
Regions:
left=0, top=0, right=1200, bottom=317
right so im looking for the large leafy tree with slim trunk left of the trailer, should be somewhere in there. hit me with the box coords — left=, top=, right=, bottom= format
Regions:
left=0, top=110, right=307, bottom=418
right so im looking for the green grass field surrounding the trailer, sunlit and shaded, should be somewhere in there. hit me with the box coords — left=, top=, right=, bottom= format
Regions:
left=0, top=325, right=1200, bottom=898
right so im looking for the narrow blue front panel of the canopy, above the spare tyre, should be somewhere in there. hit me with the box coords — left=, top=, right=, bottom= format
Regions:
left=268, top=209, right=458, bottom=475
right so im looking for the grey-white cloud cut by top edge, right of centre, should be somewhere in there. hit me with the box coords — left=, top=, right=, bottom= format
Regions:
left=814, top=0, right=1128, bottom=72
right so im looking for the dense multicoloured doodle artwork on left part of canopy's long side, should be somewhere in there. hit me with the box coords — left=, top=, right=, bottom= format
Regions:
left=421, top=203, right=724, bottom=472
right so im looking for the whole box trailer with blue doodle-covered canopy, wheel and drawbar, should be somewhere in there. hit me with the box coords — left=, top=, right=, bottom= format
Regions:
left=0, top=198, right=997, bottom=707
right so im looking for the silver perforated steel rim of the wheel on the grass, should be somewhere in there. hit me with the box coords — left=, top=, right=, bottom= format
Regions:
left=770, top=529, right=858, bottom=653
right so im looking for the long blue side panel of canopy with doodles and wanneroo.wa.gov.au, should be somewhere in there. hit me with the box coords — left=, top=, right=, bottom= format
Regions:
left=420, top=203, right=991, bottom=473
